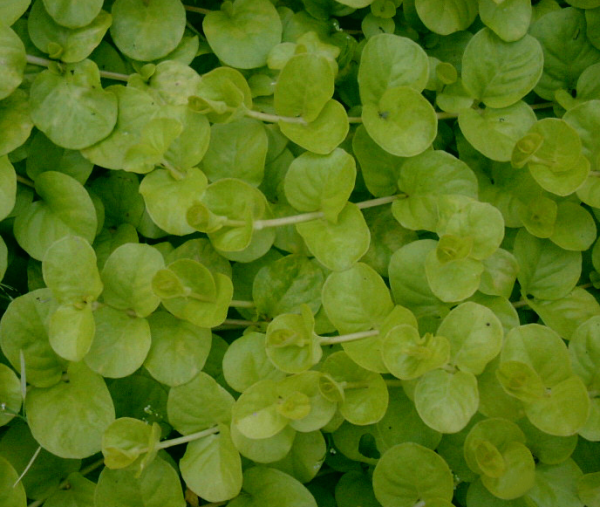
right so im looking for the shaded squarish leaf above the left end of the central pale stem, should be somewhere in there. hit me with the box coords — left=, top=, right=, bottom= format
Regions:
left=202, top=118, right=268, bottom=186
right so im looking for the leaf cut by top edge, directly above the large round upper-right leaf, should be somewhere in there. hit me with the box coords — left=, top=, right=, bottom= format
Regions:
left=479, top=0, right=532, bottom=42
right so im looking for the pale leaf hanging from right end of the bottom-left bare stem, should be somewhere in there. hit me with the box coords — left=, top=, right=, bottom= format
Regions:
left=179, top=424, right=243, bottom=502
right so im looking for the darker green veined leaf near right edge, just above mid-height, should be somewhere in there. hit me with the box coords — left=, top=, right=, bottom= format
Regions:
left=513, top=230, right=581, bottom=299
